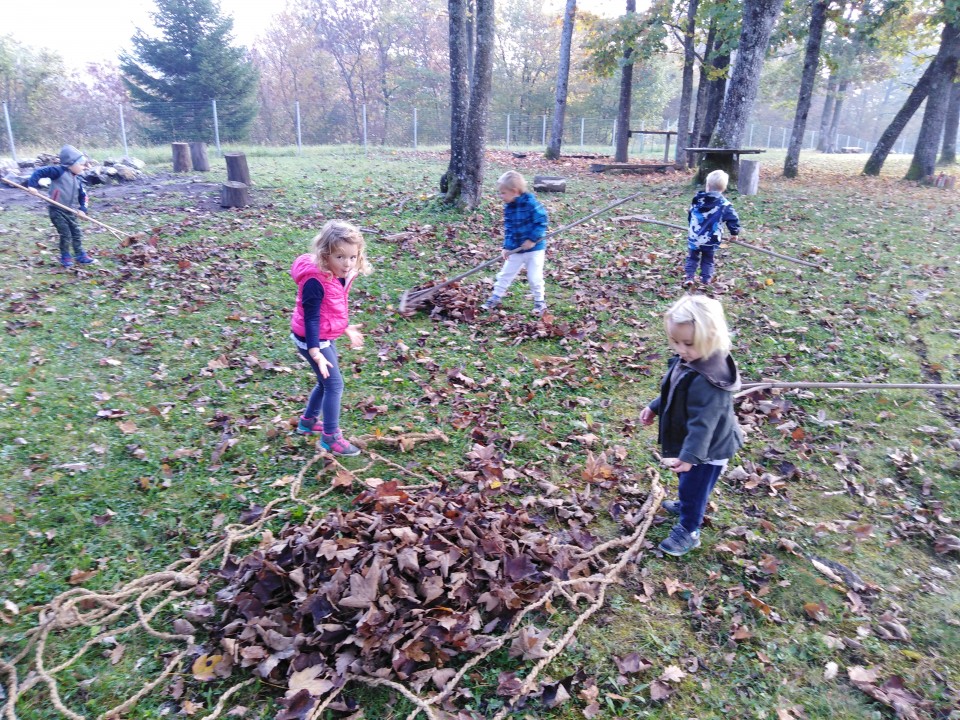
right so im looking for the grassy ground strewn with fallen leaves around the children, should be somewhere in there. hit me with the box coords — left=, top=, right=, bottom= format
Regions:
left=0, top=149, right=960, bottom=719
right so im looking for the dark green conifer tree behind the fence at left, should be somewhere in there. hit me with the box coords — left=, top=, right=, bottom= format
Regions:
left=120, top=0, right=257, bottom=140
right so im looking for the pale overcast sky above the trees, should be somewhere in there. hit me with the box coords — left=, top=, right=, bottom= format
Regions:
left=7, top=0, right=628, bottom=70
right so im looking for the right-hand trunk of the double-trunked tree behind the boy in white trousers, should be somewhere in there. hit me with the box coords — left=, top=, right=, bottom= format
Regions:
left=459, top=0, right=496, bottom=210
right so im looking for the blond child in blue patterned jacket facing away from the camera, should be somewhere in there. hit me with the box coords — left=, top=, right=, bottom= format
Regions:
left=683, top=170, right=740, bottom=290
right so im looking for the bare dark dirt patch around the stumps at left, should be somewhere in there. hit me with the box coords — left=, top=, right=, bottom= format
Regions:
left=0, top=172, right=231, bottom=212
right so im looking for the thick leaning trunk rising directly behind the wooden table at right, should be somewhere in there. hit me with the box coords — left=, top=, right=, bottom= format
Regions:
left=710, top=0, right=783, bottom=148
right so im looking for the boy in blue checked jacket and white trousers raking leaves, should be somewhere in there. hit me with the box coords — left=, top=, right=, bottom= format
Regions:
left=481, top=170, right=547, bottom=315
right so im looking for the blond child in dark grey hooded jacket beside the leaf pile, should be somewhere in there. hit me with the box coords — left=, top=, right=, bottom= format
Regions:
left=640, top=295, right=743, bottom=556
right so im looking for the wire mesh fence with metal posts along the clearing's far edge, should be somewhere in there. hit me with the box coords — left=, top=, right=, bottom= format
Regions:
left=0, top=95, right=914, bottom=160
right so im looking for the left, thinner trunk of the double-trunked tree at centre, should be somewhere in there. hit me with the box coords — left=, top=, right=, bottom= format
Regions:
left=440, top=0, right=470, bottom=197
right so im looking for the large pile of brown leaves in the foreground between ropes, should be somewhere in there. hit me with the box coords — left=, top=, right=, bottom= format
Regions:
left=213, top=481, right=598, bottom=720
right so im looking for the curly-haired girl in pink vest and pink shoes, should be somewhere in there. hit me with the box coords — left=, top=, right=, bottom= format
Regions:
left=290, top=220, right=371, bottom=455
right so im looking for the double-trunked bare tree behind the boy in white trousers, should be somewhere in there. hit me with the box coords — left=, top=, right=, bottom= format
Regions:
left=441, top=0, right=495, bottom=210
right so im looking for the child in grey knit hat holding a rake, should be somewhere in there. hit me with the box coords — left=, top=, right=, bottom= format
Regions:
left=27, top=145, right=93, bottom=267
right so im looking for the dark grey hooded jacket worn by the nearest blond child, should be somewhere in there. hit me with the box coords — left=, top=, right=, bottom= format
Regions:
left=650, top=353, right=743, bottom=465
